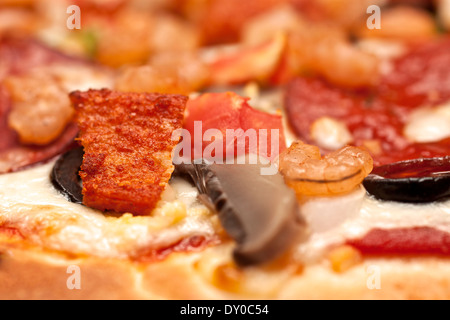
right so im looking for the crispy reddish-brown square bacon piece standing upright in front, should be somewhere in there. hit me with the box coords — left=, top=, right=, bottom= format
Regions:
left=70, top=89, right=187, bottom=214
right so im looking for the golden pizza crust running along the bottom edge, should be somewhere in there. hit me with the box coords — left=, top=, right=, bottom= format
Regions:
left=0, top=244, right=450, bottom=300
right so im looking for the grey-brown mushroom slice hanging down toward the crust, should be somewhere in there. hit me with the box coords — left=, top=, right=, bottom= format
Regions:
left=177, top=163, right=306, bottom=266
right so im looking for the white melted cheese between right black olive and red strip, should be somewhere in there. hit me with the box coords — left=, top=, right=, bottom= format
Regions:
left=297, top=191, right=450, bottom=262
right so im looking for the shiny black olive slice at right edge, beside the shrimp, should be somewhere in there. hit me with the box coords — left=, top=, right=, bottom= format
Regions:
left=363, top=157, right=450, bottom=203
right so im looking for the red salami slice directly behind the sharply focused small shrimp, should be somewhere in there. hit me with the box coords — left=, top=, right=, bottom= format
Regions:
left=285, top=78, right=408, bottom=152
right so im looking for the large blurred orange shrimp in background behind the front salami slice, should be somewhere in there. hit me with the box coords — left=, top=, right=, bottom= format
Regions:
left=241, top=5, right=380, bottom=88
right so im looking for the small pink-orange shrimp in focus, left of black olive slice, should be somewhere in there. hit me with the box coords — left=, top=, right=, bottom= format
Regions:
left=279, top=141, right=373, bottom=198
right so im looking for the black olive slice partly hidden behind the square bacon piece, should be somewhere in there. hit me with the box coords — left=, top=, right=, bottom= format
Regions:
left=50, top=147, right=84, bottom=204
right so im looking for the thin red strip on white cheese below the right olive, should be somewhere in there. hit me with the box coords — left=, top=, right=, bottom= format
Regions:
left=347, top=227, right=450, bottom=256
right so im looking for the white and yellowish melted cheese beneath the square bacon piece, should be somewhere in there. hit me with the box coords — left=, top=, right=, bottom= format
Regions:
left=0, top=162, right=215, bottom=258
